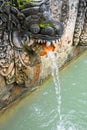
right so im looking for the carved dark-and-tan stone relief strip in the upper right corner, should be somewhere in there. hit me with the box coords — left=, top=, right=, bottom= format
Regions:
left=73, top=0, right=87, bottom=45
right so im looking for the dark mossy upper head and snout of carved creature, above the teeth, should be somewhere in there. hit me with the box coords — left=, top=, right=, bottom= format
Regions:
left=0, top=0, right=63, bottom=42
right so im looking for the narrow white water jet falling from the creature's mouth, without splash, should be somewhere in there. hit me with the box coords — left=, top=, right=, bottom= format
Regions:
left=47, top=51, right=62, bottom=130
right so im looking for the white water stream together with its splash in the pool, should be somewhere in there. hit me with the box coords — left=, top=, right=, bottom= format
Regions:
left=47, top=51, right=77, bottom=130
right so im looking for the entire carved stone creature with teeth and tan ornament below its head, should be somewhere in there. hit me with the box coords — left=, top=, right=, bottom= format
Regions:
left=0, top=0, right=63, bottom=84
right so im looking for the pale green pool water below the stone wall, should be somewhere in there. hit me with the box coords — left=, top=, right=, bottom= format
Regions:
left=0, top=52, right=87, bottom=130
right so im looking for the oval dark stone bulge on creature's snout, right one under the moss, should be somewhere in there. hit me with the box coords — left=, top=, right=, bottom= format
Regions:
left=41, top=26, right=55, bottom=36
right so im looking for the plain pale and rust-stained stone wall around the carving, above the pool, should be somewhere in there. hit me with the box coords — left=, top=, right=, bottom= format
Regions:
left=0, top=0, right=86, bottom=109
